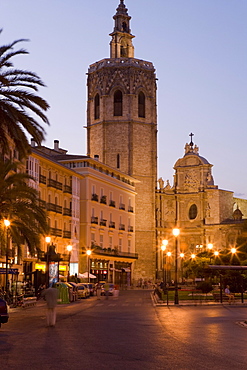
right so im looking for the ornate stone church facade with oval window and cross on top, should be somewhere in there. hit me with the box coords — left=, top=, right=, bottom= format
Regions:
left=156, top=141, right=247, bottom=277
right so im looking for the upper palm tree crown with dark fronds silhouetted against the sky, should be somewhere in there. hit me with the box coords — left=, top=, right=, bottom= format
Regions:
left=0, top=29, right=49, bottom=158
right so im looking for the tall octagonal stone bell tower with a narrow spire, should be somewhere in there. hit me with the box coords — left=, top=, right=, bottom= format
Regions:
left=87, top=0, right=157, bottom=280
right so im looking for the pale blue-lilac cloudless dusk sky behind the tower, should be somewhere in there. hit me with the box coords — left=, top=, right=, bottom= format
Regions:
left=0, top=0, right=247, bottom=198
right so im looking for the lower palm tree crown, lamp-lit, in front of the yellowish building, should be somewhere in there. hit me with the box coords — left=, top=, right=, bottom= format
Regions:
left=0, top=159, right=49, bottom=257
